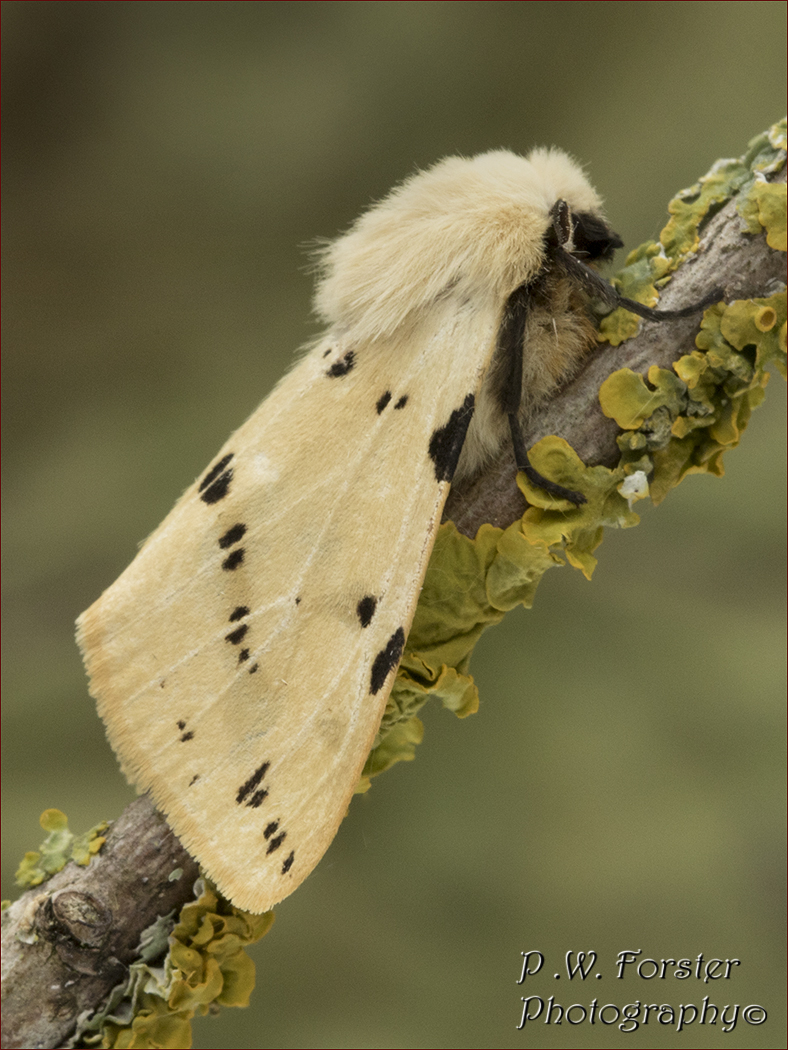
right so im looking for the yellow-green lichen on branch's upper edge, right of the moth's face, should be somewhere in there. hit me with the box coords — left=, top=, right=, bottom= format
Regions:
left=599, top=119, right=786, bottom=347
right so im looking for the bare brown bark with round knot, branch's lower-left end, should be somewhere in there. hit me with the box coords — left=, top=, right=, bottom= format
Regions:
left=2, top=797, right=200, bottom=1047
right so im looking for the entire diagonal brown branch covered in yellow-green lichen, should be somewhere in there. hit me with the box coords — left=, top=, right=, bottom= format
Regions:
left=2, top=123, right=786, bottom=1048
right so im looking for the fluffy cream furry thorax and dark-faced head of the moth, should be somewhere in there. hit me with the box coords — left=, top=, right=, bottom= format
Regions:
left=315, top=149, right=621, bottom=341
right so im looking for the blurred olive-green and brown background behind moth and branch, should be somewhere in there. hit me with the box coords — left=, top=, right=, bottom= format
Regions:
left=2, top=0, right=786, bottom=1047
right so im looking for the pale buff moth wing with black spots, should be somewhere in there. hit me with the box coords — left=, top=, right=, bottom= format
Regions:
left=78, top=296, right=500, bottom=911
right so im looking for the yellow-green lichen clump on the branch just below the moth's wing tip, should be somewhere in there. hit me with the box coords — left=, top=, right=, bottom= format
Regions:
left=67, top=879, right=273, bottom=1050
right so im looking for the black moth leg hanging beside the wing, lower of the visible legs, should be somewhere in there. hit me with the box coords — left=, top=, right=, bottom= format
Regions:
left=498, top=285, right=586, bottom=507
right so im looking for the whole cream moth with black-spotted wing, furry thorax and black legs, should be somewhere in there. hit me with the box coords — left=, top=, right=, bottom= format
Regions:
left=78, top=149, right=714, bottom=911
